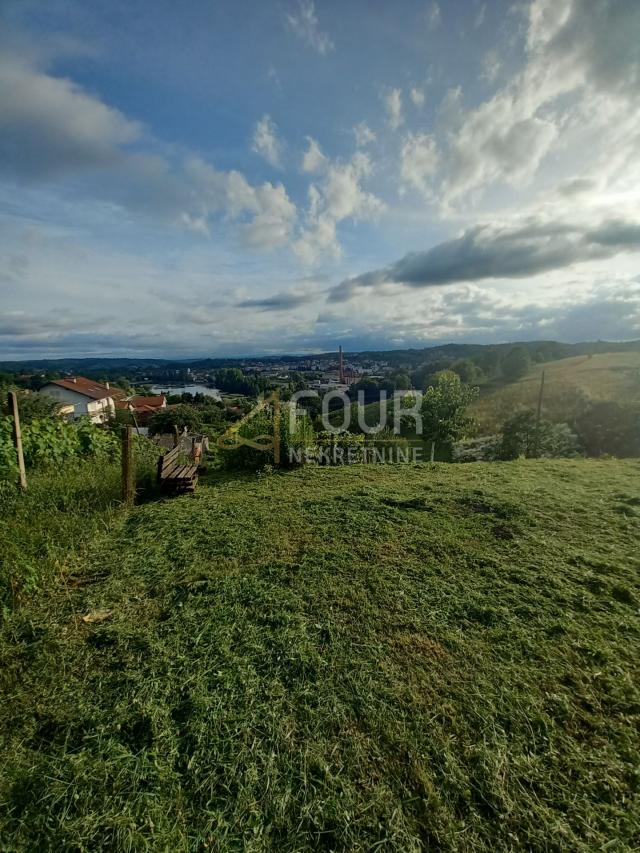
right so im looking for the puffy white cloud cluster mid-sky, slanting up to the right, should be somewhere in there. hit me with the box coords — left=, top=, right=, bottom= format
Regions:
left=293, top=151, right=384, bottom=264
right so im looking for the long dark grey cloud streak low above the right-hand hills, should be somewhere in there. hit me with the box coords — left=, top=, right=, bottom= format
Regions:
left=332, top=212, right=640, bottom=301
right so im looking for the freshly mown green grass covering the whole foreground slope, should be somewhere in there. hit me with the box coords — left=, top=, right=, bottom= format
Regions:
left=0, top=460, right=640, bottom=851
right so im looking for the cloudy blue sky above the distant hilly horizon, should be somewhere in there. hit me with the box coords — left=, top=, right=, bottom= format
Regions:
left=0, top=0, right=640, bottom=359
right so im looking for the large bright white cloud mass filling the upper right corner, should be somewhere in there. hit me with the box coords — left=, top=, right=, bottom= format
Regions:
left=441, top=0, right=640, bottom=205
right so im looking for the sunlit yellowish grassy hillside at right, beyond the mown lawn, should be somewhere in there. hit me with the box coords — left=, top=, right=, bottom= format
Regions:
left=470, top=352, right=640, bottom=433
